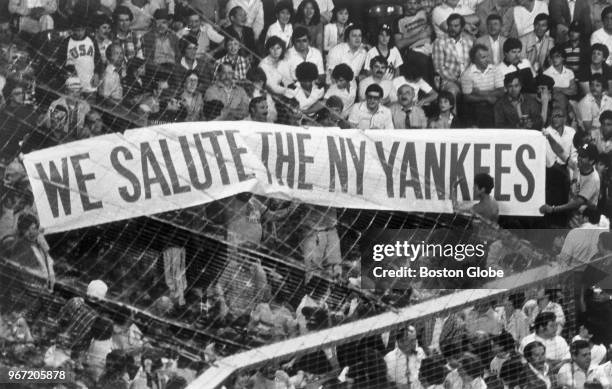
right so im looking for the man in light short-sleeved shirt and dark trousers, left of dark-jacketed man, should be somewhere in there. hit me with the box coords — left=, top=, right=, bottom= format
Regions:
left=461, top=44, right=504, bottom=128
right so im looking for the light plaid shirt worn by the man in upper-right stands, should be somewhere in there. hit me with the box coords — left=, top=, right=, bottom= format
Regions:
left=433, top=35, right=474, bottom=82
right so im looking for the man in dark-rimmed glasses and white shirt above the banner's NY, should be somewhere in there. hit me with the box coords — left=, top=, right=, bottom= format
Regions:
left=348, top=84, right=394, bottom=130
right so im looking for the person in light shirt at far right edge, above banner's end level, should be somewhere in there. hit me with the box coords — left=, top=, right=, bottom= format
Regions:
left=577, top=74, right=612, bottom=140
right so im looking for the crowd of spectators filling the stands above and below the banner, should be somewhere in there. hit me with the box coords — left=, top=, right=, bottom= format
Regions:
left=0, top=0, right=612, bottom=389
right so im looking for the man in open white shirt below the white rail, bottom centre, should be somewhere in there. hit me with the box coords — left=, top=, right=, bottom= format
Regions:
left=385, top=325, right=427, bottom=388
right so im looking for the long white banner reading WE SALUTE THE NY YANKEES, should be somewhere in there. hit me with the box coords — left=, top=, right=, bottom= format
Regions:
left=24, top=121, right=546, bottom=233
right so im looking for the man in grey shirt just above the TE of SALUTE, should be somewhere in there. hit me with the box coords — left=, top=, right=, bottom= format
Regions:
left=204, top=64, right=249, bottom=120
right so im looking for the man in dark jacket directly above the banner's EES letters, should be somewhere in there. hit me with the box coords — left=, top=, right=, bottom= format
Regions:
left=495, top=73, right=543, bottom=130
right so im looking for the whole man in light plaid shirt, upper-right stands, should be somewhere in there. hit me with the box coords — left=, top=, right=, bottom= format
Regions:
left=433, top=14, right=474, bottom=97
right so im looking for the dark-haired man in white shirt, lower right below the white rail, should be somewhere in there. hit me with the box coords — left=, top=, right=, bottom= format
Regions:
left=519, top=312, right=570, bottom=370
